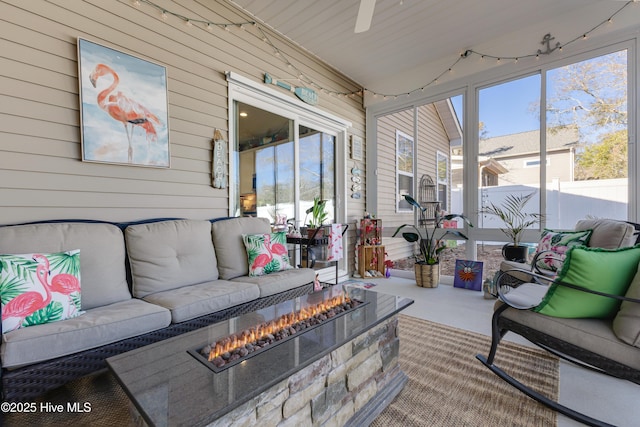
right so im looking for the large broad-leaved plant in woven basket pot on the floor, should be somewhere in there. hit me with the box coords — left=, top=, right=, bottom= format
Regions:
left=392, top=195, right=473, bottom=288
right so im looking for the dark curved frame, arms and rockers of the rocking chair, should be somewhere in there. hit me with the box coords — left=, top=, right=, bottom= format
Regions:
left=476, top=270, right=640, bottom=427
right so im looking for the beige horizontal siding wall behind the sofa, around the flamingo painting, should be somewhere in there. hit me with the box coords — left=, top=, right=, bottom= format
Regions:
left=0, top=0, right=365, bottom=227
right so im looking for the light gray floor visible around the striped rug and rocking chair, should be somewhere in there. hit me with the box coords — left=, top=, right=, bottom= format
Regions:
left=360, top=271, right=640, bottom=427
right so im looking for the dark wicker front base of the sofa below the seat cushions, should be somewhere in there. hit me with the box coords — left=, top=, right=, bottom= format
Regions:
left=1, top=283, right=313, bottom=402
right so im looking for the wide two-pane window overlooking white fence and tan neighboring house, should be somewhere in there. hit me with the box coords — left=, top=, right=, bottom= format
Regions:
left=478, top=50, right=629, bottom=241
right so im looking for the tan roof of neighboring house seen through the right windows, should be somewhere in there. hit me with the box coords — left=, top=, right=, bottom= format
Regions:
left=479, top=127, right=579, bottom=159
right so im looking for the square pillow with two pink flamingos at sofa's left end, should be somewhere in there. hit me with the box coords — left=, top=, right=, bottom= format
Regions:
left=0, top=250, right=82, bottom=333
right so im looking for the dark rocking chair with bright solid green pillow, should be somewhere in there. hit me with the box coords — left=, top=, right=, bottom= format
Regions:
left=476, top=245, right=640, bottom=426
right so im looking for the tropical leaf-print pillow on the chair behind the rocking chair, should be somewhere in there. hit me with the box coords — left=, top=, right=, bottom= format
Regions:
left=536, top=228, right=593, bottom=272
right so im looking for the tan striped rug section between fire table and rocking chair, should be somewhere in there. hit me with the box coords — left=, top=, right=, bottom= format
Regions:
left=372, top=315, right=559, bottom=427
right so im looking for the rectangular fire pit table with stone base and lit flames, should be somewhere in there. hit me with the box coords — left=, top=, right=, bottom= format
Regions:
left=107, top=286, right=413, bottom=426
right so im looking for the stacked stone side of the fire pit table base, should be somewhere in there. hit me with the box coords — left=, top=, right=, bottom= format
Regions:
left=209, top=316, right=406, bottom=427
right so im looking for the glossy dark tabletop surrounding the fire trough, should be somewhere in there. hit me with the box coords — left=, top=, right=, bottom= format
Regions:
left=107, top=286, right=413, bottom=426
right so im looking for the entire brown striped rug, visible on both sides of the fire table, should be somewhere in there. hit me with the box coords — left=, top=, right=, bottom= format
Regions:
left=0, top=315, right=558, bottom=427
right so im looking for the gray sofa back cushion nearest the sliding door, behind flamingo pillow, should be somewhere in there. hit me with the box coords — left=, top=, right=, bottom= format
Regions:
left=211, top=217, right=271, bottom=280
